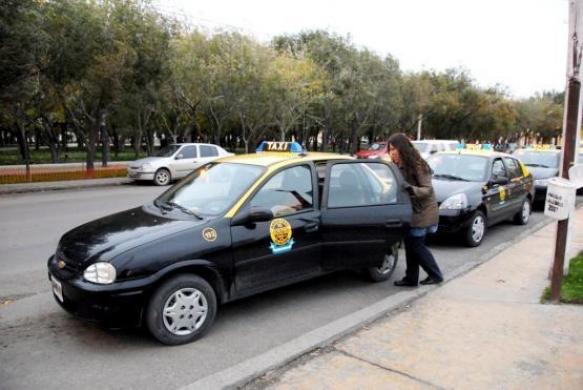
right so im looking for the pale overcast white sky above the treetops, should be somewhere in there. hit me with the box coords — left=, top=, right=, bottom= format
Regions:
left=154, top=0, right=568, bottom=98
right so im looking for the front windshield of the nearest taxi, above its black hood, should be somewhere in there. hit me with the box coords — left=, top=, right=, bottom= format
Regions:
left=155, top=163, right=265, bottom=216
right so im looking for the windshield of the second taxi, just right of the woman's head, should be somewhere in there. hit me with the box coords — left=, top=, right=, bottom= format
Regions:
left=427, top=154, right=488, bottom=181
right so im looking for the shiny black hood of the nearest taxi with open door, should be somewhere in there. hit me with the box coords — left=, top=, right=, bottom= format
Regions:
left=57, top=205, right=204, bottom=266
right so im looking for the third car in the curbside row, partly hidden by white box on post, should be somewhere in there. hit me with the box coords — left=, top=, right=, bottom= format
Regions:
left=513, top=145, right=561, bottom=203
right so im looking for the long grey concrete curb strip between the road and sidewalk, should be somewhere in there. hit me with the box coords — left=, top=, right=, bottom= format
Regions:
left=180, top=215, right=554, bottom=390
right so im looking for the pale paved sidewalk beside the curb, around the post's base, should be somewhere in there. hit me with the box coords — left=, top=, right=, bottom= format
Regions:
left=253, top=209, right=583, bottom=389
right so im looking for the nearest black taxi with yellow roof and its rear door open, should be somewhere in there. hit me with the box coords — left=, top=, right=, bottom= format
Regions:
left=48, top=142, right=412, bottom=345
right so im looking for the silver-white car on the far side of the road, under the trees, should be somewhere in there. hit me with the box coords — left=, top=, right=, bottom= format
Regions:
left=128, top=144, right=233, bottom=186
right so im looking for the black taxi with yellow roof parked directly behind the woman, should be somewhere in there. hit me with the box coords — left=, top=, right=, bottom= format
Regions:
left=428, top=145, right=534, bottom=247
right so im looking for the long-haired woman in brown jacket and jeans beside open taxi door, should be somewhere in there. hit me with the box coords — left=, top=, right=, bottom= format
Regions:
left=389, top=133, right=443, bottom=286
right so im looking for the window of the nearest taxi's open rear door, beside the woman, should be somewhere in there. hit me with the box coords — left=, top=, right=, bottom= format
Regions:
left=328, top=163, right=397, bottom=208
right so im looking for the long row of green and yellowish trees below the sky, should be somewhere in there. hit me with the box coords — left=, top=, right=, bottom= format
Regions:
left=0, top=0, right=563, bottom=168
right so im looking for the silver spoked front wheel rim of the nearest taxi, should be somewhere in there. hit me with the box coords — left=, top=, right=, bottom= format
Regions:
left=162, top=288, right=208, bottom=336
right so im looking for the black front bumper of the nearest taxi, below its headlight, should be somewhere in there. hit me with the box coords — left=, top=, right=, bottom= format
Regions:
left=48, top=256, right=147, bottom=327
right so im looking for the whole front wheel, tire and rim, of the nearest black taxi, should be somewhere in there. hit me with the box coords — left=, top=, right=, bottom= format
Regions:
left=145, top=274, right=217, bottom=345
